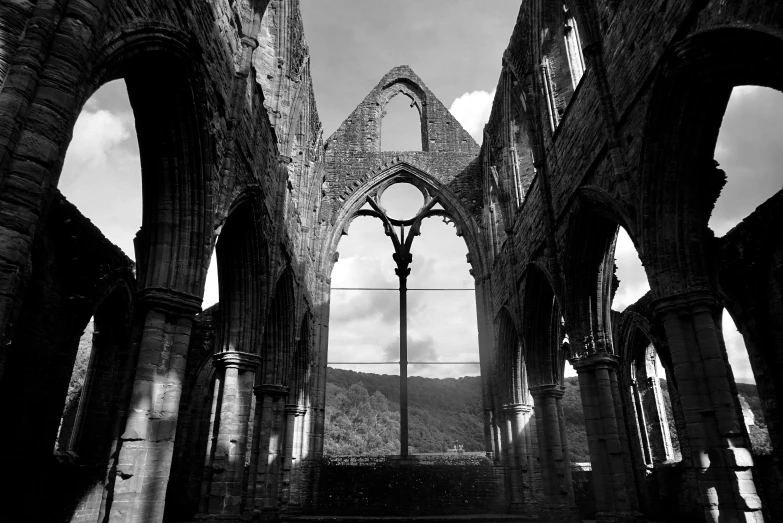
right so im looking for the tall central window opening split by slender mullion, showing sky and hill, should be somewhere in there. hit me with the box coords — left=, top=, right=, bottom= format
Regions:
left=324, top=181, right=485, bottom=455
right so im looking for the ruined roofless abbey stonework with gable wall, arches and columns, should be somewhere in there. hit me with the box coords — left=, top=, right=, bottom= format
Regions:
left=0, top=0, right=783, bottom=523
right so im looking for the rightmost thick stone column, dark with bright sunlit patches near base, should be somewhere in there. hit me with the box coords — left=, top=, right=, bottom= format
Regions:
left=655, top=292, right=764, bottom=523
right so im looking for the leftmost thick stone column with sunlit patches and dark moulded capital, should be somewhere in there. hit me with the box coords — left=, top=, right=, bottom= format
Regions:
left=109, top=289, right=201, bottom=523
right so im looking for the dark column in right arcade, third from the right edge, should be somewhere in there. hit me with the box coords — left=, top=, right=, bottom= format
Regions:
left=530, top=385, right=579, bottom=521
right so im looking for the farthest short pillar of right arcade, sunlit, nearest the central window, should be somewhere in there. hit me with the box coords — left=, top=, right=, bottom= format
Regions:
left=503, top=403, right=533, bottom=512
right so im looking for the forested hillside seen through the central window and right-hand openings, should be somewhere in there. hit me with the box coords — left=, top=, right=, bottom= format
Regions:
left=324, top=367, right=769, bottom=463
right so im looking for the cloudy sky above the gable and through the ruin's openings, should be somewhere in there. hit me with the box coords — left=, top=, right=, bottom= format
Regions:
left=55, top=0, right=783, bottom=381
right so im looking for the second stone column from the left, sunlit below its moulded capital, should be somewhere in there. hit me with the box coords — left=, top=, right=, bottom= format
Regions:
left=196, top=351, right=261, bottom=521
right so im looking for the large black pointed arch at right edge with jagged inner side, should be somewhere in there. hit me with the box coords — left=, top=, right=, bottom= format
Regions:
left=639, top=27, right=783, bottom=293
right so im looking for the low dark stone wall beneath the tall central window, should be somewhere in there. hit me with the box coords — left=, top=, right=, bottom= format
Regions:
left=298, top=455, right=508, bottom=516
